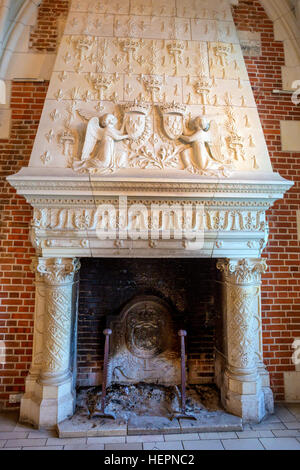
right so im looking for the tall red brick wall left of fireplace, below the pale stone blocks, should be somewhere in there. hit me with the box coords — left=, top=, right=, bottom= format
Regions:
left=0, top=82, right=48, bottom=407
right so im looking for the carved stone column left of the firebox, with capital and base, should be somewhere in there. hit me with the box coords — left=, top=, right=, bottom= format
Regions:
left=20, top=258, right=80, bottom=427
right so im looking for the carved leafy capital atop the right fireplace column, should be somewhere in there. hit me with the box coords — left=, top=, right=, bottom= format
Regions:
left=217, top=258, right=268, bottom=284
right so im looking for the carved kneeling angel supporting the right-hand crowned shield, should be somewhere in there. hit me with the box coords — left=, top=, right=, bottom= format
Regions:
left=180, top=116, right=229, bottom=173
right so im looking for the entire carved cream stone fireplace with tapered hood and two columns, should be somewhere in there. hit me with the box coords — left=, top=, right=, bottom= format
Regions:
left=8, top=0, right=292, bottom=427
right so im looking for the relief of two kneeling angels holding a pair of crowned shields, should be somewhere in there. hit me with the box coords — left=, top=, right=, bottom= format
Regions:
left=67, top=100, right=241, bottom=177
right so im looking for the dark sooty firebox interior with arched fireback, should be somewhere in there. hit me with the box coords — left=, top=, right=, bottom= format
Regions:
left=77, top=258, right=220, bottom=386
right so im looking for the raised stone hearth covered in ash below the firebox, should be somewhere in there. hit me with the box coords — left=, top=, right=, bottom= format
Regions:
left=58, top=384, right=243, bottom=437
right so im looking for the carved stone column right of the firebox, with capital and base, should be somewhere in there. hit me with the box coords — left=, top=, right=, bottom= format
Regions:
left=217, top=259, right=273, bottom=422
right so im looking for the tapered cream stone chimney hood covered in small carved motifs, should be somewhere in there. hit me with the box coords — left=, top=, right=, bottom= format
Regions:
left=28, top=0, right=266, bottom=177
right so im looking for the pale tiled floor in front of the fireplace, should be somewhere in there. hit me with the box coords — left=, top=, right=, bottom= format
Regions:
left=0, top=404, right=300, bottom=450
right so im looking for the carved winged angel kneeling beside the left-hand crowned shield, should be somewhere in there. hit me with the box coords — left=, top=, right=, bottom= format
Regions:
left=74, top=114, right=130, bottom=173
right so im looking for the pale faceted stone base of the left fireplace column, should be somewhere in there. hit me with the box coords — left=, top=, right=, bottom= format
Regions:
left=20, top=375, right=75, bottom=429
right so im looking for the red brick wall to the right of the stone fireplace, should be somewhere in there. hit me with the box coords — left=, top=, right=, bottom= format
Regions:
left=233, top=0, right=300, bottom=400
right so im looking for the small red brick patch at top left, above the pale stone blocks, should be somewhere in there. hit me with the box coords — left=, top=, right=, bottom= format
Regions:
left=30, top=0, right=69, bottom=52
